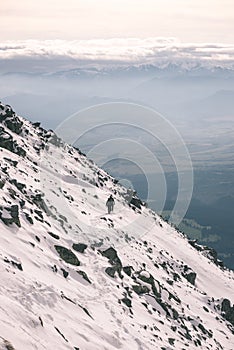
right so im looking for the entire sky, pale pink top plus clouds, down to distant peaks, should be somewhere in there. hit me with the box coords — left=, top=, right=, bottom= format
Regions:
left=0, top=0, right=234, bottom=72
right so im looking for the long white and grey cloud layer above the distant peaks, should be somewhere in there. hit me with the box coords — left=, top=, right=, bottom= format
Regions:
left=0, top=37, right=234, bottom=69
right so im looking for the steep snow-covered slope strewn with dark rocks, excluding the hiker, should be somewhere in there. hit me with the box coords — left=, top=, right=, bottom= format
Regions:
left=0, top=104, right=234, bottom=350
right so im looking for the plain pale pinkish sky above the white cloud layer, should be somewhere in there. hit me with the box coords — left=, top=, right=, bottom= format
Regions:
left=0, top=0, right=234, bottom=44
